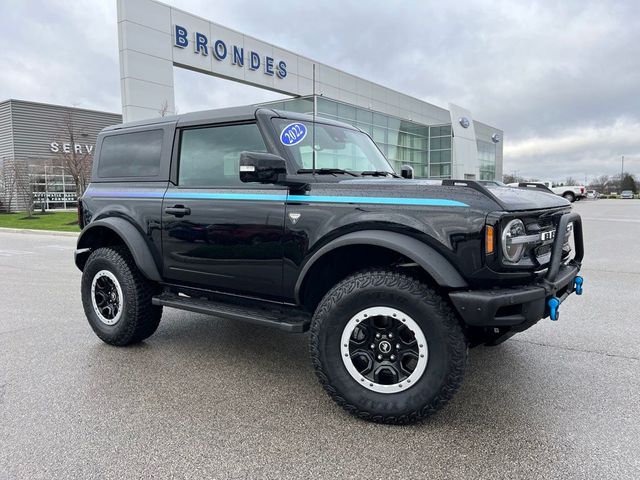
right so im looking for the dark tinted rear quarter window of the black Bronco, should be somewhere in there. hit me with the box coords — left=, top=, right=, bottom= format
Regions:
left=98, top=130, right=163, bottom=178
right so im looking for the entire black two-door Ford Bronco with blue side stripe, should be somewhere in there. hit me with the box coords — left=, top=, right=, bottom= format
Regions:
left=75, top=107, right=583, bottom=423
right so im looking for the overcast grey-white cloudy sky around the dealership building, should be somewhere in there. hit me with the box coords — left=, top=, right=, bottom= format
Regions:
left=0, top=0, right=640, bottom=180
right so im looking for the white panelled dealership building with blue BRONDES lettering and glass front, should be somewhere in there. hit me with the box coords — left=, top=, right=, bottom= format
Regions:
left=118, top=0, right=503, bottom=180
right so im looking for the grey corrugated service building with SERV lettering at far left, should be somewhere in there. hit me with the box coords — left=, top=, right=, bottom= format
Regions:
left=0, top=99, right=122, bottom=211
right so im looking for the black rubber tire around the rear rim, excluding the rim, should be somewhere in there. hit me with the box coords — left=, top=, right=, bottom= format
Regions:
left=81, top=246, right=162, bottom=347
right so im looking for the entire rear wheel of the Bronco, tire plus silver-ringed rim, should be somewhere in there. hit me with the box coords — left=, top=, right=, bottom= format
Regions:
left=81, top=246, right=162, bottom=346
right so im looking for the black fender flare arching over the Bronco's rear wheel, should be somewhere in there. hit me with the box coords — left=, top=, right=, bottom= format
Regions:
left=76, top=217, right=162, bottom=282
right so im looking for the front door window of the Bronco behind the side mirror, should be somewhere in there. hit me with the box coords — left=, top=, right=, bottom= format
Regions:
left=178, top=123, right=267, bottom=187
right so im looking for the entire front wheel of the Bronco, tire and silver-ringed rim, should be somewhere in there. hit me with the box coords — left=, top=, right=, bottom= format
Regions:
left=310, top=270, right=467, bottom=423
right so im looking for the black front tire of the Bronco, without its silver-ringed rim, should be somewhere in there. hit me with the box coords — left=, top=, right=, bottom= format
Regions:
left=310, top=270, right=468, bottom=424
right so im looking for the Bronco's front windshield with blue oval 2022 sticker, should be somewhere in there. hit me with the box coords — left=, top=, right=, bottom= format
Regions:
left=273, top=118, right=395, bottom=173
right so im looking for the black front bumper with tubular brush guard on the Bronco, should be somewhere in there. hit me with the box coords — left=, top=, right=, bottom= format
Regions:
left=449, top=212, right=584, bottom=331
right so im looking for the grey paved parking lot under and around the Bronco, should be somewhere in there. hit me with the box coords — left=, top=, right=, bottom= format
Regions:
left=0, top=200, right=640, bottom=480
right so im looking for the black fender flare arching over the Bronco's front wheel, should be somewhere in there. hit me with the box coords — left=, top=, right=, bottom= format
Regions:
left=295, top=230, right=468, bottom=303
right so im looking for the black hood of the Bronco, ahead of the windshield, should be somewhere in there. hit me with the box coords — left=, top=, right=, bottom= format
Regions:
left=330, top=178, right=570, bottom=212
